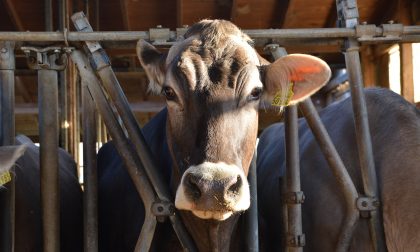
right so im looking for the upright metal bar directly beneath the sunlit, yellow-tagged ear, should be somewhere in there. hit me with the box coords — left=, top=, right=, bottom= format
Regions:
left=285, top=105, right=303, bottom=252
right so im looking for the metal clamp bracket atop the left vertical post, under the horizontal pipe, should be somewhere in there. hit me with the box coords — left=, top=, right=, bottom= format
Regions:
left=20, top=46, right=74, bottom=71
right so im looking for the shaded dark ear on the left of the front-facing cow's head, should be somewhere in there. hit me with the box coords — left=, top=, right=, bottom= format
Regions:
left=136, top=39, right=166, bottom=94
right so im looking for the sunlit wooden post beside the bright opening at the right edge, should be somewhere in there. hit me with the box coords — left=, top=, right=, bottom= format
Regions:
left=400, top=43, right=414, bottom=102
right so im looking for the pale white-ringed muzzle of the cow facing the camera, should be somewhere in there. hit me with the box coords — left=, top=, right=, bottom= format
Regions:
left=175, top=162, right=250, bottom=220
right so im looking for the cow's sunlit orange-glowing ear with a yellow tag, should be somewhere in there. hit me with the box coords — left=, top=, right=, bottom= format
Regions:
left=263, top=54, right=331, bottom=106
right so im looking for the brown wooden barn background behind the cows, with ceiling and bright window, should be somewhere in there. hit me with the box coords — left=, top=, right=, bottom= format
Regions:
left=0, top=0, right=420, bottom=161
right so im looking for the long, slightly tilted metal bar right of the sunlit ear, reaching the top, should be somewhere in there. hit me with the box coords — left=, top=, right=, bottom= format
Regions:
left=336, top=0, right=388, bottom=251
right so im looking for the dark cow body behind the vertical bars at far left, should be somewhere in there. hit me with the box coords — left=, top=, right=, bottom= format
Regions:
left=0, top=135, right=83, bottom=252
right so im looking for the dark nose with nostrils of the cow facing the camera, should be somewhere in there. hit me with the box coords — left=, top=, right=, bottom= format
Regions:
left=184, top=173, right=243, bottom=203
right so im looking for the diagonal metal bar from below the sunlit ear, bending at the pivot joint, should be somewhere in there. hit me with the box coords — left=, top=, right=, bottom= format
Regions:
left=299, top=99, right=359, bottom=252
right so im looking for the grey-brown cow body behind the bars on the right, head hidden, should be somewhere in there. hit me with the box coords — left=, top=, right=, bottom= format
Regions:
left=257, top=89, right=420, bottom=251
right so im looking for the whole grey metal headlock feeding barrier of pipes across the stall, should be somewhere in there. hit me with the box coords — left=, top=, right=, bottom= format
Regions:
left=0, top=0, right=420, bottom=252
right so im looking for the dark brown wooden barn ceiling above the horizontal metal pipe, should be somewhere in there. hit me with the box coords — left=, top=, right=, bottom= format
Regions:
left=0, top=0, right=420, bottom=139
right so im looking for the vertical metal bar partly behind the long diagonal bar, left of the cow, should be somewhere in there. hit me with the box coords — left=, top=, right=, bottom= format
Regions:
left=82, top=83, right=98, bottom=252
